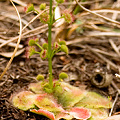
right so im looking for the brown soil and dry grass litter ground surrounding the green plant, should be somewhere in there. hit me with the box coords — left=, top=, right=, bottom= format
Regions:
left=0, top=0, right=120, bottom=120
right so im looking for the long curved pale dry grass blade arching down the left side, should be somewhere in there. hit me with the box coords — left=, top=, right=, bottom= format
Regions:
left=0, top=0, right=22, bottom=80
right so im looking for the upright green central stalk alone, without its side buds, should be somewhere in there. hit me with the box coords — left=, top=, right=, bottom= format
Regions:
left=48, top=0, right=53, bottom=89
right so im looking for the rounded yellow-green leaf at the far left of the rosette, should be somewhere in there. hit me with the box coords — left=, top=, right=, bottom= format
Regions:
left=12, top=91, right=37, bottom=111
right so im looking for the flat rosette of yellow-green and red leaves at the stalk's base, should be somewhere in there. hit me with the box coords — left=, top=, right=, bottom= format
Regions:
left=13, top=81, right=111, bottom=120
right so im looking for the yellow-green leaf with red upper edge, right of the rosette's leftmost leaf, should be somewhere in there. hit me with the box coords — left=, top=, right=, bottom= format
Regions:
left=34, top=94, right=64, bottom=112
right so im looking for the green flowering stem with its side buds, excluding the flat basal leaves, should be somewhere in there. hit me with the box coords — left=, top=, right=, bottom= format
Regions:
left=27, top=0, right=72, bottom=93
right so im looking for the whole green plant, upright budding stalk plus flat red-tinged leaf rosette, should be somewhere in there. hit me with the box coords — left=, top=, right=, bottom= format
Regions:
left=13, top=0, right=111, bottom=120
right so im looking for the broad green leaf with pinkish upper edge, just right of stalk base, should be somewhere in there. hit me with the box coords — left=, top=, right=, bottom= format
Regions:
left=54, top=82, right=86, bottom=107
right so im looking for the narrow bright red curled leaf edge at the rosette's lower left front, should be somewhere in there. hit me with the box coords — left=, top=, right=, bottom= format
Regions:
left=30, top=109, right=55, bottom=120
